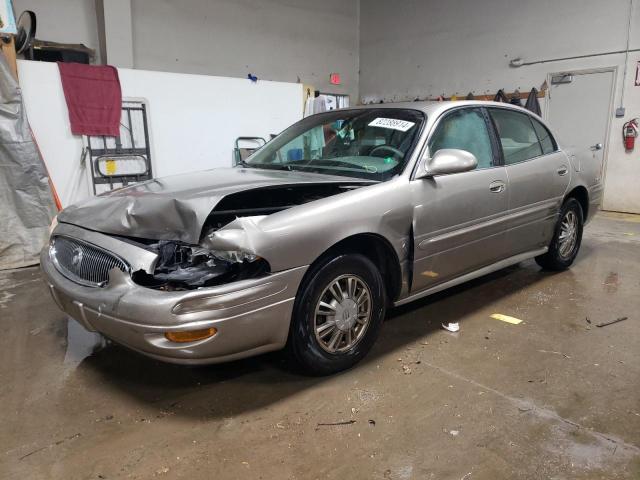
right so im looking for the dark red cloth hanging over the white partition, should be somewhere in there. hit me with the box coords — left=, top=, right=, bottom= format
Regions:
left=58, top=62, right=122, bottom=137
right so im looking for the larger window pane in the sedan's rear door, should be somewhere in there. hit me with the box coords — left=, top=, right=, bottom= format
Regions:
left=490, top=108, right=542, bottom=165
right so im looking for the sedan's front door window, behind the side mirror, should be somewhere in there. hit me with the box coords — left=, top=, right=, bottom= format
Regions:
left=429, top=108, right=493, bottom=168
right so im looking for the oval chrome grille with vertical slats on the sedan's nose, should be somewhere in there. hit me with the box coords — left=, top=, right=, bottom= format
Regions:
left=49, top=236, right=129, bottom=287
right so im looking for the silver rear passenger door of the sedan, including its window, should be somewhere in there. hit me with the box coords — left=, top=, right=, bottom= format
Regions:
left=489, top=107, right=571, bottom=255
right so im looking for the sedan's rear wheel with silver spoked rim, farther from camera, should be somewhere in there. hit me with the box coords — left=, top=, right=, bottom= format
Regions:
left=536, top=198, right=584, bottom=271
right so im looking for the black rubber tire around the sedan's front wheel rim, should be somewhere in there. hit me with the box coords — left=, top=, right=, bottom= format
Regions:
left=287, top=253, right=385, bottom=376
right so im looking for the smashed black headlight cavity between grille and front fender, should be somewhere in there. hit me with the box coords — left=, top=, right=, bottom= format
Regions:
left=133, top=241, right=269, bottom=290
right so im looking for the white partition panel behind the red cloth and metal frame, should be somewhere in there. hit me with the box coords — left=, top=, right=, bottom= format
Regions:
left=18, top=61, right=302, bottom=206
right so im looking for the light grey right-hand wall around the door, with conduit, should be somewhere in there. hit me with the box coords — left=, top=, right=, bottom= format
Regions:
left=359, top=0, right=640, bottom=213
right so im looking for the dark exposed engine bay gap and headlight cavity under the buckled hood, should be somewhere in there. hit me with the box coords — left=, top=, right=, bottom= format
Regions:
left=129, top=182, right=370, bottom=291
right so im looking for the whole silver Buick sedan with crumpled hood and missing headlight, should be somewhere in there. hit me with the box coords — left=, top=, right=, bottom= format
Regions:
left=41, top=101, right=602, bottom=374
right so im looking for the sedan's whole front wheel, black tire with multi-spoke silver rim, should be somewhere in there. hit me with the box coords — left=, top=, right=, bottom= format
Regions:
left=287, top=254, right=385, bottom=375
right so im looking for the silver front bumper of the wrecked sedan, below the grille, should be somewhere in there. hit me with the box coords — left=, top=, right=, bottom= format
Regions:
left=40, top=226, right=307, bottom=364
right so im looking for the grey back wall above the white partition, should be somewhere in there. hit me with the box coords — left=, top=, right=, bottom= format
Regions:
left=14, top=0, right=359, bottom=103
